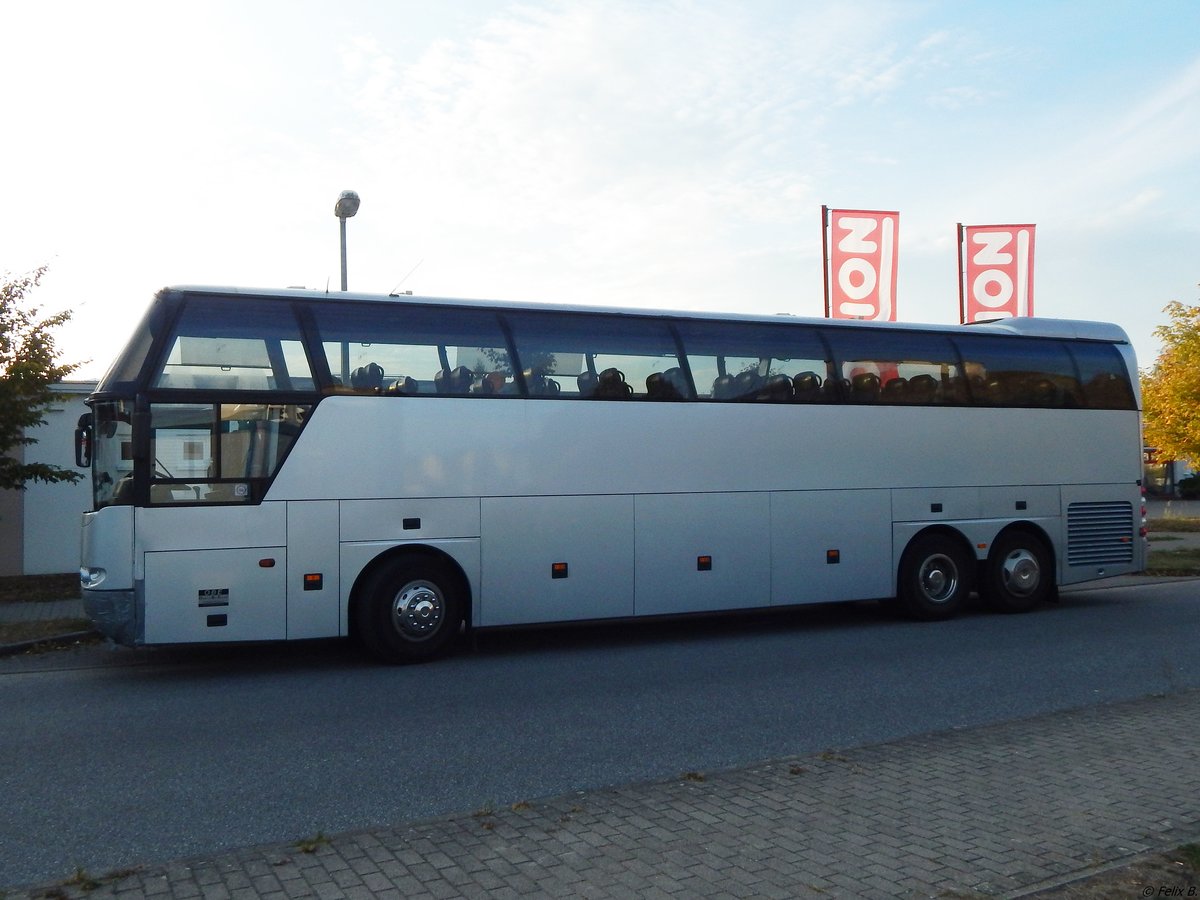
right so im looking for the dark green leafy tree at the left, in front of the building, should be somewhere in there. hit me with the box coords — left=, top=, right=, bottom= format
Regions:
left=0, top=265, right=83, bottom=490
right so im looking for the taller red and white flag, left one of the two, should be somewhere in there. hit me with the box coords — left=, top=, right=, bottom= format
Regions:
left=821, top=206, right=900, bottom=322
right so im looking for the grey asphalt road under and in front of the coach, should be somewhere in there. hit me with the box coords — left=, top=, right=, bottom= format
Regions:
left=0, top=581, right=1200, bottom=889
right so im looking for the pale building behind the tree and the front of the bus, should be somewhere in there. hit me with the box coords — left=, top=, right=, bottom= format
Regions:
left=0, top=382, right=96, bottom=575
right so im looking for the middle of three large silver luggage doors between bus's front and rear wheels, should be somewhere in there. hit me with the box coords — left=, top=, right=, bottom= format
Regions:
left=634, top=493, right=770, bottom=616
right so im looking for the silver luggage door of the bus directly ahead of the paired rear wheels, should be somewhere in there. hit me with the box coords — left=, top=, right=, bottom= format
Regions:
left=770, top=490, right=894, bottom=605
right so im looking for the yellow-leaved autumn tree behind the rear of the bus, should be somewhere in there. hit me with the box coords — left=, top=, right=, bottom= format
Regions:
left=1141, top=300, right=1200, bottom=468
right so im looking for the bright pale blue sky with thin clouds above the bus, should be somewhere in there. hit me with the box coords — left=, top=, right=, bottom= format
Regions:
left=0, top=0, right=1200, bottom=378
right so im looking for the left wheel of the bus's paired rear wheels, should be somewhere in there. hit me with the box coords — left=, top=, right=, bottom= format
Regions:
left=896, top=532, right=973, bottom=622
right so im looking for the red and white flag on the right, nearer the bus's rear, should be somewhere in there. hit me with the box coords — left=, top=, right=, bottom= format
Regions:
left=959, top=224, right=1034, bottom=323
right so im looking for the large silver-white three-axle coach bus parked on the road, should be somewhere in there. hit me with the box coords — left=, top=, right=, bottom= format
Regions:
left=77, top=287, right=1145, bottom=662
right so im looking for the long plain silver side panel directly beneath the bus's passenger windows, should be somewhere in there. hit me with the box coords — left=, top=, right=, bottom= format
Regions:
left=268, top=396, right=1141, bottom=500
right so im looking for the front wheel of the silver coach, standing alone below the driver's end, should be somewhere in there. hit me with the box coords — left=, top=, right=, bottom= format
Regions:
left=354, top=556, right=463, bottom=664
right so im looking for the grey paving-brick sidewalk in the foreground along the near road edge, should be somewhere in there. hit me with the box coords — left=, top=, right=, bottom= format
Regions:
left=7, top=686, right=1200, bottom=900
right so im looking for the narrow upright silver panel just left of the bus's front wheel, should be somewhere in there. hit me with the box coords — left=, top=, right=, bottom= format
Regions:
left=287, top=500, right=341, bottom=641
